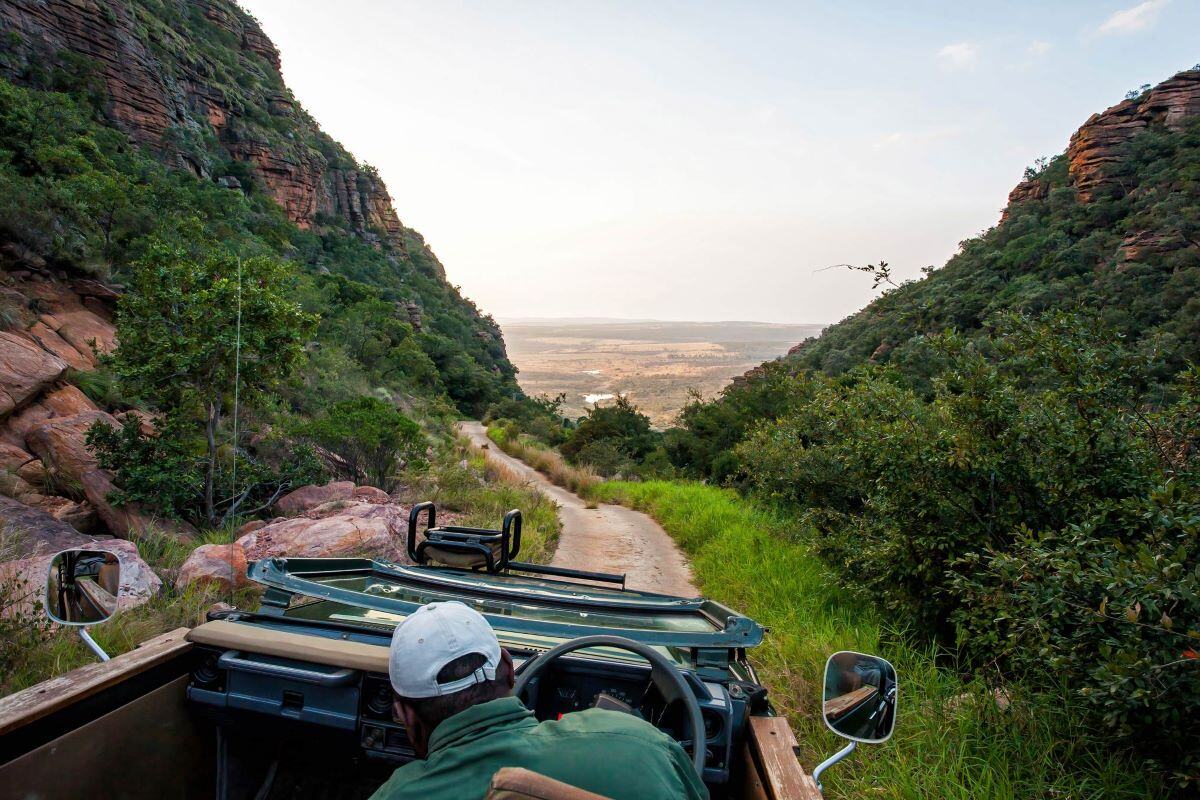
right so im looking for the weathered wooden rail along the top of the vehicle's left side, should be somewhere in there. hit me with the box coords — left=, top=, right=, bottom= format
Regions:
left=0, top=627, right=192, bottom=734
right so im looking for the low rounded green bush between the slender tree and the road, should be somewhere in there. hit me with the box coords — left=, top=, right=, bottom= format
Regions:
left=296, top=397, right=426, bottom=492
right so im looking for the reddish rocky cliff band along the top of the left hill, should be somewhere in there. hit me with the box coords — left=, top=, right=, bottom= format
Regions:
left=0, top=0, right=404, bottom=251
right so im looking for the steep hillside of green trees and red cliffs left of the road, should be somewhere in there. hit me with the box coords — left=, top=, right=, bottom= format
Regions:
left=0, top=0, right=518, bottom=413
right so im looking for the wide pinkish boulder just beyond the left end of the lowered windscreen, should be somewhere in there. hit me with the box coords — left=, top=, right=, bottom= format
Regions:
left=236, top=500, right=408, bottom=560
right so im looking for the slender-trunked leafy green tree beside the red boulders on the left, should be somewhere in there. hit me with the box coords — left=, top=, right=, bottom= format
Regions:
left=108, top=242, right=316, bottom=524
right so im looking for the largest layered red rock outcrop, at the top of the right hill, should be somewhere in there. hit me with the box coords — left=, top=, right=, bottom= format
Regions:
left=1067, top=70, right=1200, bottom=203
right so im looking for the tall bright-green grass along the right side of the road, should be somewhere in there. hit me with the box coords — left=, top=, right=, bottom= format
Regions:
left=594, top=481, right=1164, bottom=800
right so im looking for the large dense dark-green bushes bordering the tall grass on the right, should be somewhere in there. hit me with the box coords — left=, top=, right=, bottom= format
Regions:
left=737, top=315, right=1200, bottom=786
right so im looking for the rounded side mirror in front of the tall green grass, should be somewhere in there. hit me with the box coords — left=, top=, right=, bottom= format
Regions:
left=822, top=650, right=896, bottom=744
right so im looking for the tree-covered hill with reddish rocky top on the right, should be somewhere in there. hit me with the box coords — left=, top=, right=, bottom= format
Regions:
left=790, top=70, right=1200, bottom=380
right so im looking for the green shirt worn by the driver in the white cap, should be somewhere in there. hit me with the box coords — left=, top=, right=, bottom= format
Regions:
left=371, top=697, right=708, bottom=800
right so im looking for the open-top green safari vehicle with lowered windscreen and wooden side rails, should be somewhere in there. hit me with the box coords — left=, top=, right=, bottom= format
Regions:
left=0, top=504, right=895, bottom=800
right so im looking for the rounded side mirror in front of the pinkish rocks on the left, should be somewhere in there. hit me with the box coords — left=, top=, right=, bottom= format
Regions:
left=44, top=549, right=121, bottom=625
